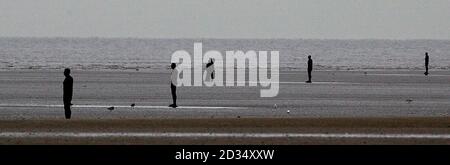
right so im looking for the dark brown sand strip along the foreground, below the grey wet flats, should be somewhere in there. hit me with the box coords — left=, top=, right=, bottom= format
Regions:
left=0, top=117, right=450, bottom=144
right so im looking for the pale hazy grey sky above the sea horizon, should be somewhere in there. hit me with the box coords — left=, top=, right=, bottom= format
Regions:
left=0, top=0, right=450, bottom=39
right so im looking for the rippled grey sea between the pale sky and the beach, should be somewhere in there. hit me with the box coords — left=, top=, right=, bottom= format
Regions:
left=0, top=38, right=450, bottom=70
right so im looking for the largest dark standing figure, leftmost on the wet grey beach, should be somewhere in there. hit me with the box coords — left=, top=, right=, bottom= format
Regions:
left=63, top=68, right=73, bottom=119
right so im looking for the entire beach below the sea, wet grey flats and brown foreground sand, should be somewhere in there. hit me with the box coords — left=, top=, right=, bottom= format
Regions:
left=0, top=70, right=450, bottom=144
